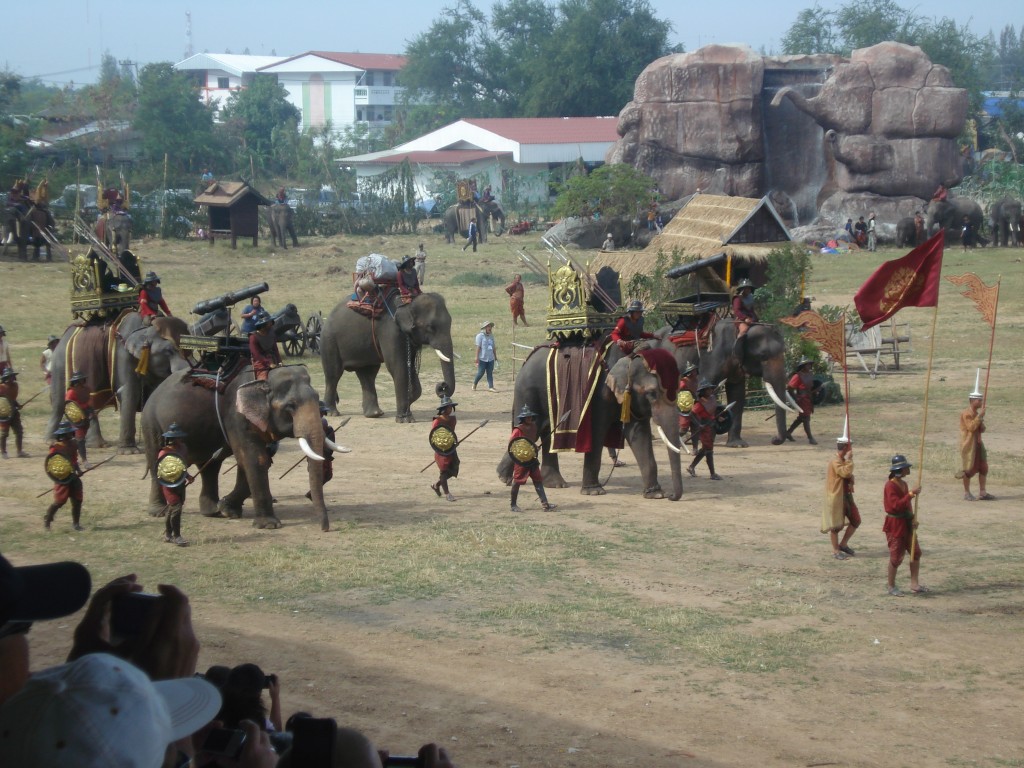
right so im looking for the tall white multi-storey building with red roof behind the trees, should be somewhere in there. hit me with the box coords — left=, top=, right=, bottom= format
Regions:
left=259, top=51, right=406, bottom=131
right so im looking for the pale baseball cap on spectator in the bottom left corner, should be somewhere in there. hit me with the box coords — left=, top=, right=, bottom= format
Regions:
left=0, top=653, right=220, bottom=768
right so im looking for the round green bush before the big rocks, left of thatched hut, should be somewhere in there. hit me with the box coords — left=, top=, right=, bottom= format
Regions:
left=554, top=164, right=656, bottom=217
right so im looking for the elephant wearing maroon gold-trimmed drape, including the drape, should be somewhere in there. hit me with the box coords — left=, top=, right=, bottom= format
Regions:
left=498, top=339, right=683, bottom=501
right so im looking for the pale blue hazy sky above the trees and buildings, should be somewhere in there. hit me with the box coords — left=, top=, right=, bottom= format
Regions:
left=0, top=0, right=1024, bottom=85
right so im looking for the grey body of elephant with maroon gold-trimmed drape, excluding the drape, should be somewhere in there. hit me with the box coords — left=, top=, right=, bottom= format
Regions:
left=498, top=347, right=683, bottom=501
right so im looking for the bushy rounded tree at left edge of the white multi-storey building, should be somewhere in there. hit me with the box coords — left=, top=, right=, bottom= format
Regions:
left=133, top=61, right=216, bottom=171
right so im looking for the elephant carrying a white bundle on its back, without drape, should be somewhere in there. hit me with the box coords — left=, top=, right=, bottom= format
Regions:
left=321, top=291, right=455, bottom=422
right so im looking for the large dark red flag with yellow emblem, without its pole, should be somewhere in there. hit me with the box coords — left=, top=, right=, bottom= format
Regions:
left=853, top=229, right=945, bottom=331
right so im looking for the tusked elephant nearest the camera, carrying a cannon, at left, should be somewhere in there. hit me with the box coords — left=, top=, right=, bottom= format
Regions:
left=142, top=366, right=329, bottom=531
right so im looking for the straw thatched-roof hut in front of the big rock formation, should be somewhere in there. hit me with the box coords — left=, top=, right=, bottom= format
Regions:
left=592, top=195, right=792, bottom=284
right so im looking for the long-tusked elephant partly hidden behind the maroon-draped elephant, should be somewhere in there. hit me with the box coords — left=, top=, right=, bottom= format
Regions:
left=654, top=317, right=793, bottom=447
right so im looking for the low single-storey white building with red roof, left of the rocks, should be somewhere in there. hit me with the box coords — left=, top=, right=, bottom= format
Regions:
left=338, top=117, right=618, bottom=204
